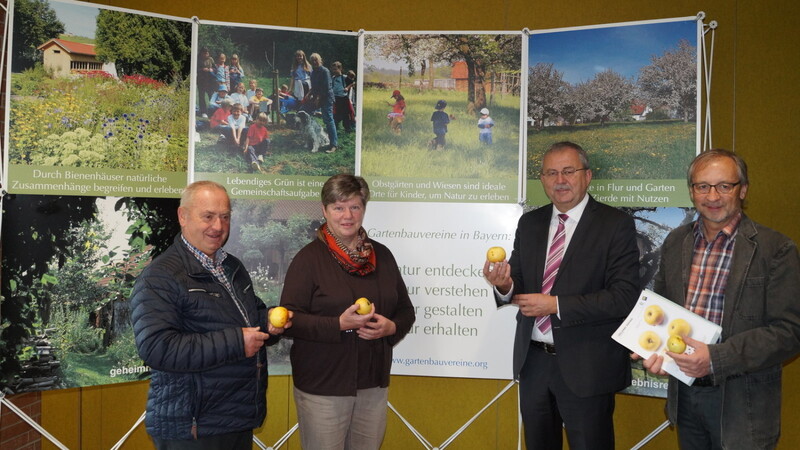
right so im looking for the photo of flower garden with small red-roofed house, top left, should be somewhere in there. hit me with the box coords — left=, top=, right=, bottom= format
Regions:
left=7, top=0, right=192, bottom=179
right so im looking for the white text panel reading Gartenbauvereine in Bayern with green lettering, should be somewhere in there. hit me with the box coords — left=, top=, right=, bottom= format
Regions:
left=364, top=202, right=522, bottom=379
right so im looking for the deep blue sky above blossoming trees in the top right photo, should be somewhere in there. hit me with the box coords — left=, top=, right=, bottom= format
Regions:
left=528, top=20, right=697, bottom=84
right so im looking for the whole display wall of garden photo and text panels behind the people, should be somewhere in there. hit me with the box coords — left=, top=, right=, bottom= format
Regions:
left=0, top=0, right=698, bottom=395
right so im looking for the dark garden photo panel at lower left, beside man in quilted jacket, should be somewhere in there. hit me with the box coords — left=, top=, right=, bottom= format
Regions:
left=0, top=194, right=180, bottom=393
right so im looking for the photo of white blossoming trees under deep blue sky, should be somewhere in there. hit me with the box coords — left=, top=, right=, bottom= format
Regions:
left=527, top=19, right=699, bottom=188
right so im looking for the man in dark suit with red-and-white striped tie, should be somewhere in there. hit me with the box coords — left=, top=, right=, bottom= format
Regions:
left=484, top=142, right=640, bottom=450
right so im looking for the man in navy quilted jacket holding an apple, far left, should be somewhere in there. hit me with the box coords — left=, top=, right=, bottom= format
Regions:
left=131, top=181, right=291, bottom=450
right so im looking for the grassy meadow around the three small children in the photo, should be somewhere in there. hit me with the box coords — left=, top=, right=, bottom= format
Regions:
left=361, top=89, right=520, bottom=179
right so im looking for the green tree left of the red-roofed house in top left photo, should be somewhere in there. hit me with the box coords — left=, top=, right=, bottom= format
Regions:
left=11, top=0, right=64, bottom=72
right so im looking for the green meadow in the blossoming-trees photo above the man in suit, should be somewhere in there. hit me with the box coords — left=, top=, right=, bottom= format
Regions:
left=527, top=121, right=695, bottom=180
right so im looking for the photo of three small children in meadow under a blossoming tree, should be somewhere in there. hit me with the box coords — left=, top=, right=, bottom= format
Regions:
left=361, top=33, right=522, bottom=182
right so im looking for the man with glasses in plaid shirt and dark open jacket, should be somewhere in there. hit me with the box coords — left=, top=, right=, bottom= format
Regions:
left=644, top=149, right=800, bottom=450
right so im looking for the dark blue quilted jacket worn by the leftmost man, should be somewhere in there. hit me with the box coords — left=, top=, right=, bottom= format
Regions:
left=131, top=236, right=270, bottom=439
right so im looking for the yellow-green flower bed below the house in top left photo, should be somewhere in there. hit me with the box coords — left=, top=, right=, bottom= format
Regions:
left=9, top=69, right=189, bottom=172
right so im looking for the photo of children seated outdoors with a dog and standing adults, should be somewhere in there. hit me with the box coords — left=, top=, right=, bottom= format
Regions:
left=194, top=24, right=358, bottom=176
